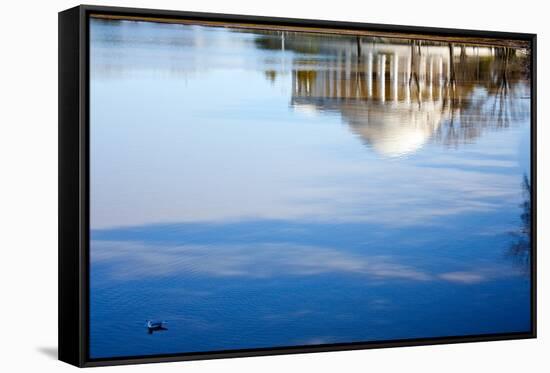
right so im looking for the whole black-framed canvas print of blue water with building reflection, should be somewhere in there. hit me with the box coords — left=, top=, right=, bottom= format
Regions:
left=59, top=6, right=536, bottom=366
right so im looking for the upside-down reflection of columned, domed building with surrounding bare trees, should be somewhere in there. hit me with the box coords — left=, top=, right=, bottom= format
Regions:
left=278, top=35, right=529, bottom=156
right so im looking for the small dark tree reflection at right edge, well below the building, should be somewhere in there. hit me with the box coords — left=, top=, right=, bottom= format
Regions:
left=508, top=175, right=531, bottom=271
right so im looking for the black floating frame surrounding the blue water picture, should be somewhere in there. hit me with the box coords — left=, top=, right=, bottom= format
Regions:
left=58, top=5, right=537, bottom=367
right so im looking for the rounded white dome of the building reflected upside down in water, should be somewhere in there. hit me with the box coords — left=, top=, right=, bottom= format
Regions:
left=342, top=102, right=446, bottom=157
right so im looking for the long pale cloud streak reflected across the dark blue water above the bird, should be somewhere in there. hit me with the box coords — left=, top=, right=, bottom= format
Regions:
left=91, top=237, right=519, bottom=284
